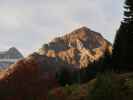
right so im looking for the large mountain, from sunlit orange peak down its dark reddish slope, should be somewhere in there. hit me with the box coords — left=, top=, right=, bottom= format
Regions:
left=0, top=27, right=112, bottom=100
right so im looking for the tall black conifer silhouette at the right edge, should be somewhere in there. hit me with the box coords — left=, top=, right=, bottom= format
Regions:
left=112, top=0, right=133, bottom=68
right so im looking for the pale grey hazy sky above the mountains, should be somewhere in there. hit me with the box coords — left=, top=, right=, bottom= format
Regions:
left=0, top=0, right=123, bottom=55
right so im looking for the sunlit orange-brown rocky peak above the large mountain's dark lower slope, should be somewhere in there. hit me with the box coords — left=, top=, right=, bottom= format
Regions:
left=37, top=27, right=112, bottom=68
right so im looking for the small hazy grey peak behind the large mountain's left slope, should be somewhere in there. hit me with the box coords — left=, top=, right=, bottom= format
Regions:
left=0, top=47, right=23, bottom=69
